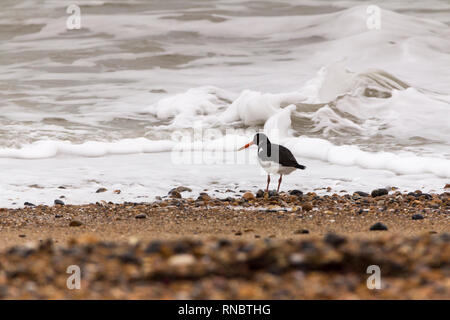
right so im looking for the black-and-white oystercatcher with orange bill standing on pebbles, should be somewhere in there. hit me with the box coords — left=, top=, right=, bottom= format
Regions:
left=238, top=133, right=306, bottom=192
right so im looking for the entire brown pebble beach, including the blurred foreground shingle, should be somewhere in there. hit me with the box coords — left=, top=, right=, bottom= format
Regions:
left=0, top=191, right=450, bottom=299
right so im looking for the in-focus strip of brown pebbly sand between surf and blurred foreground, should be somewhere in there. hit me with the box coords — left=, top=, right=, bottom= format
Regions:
left=0, top=187, right=450, bottom=242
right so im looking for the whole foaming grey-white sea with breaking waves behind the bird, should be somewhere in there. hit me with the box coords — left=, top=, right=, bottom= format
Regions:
left=0, top=0, right=450, bottom=207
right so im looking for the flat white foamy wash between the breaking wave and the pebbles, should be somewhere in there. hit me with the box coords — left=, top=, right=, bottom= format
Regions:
left=0, top=152, right=450, bottom=208
